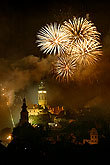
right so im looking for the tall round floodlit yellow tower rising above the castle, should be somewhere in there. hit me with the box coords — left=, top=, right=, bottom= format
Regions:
left=38, top=81, right=47, bottom=108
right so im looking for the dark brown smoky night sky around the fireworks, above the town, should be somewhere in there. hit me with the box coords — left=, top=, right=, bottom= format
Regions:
left=0, top=0, right=110, bottom=128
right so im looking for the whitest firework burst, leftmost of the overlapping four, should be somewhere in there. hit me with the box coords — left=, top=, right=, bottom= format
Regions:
left=36, top=23, right=67, bottom=55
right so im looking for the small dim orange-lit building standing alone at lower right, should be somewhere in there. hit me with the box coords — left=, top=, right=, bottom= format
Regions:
left=83, top=128, right=98, bottom=144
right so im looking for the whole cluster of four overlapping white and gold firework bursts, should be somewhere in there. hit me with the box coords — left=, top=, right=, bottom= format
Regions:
left=37, top=17, right=102, bottom=81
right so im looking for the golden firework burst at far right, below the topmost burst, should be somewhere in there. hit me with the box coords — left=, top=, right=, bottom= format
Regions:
left=72, top=39, right=102, bottom=65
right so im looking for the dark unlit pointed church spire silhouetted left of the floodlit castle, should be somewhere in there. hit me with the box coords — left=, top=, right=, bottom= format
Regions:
left=20, top=98, right=28, bottom=124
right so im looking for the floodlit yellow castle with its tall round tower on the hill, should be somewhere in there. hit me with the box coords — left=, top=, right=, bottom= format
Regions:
left=27, top=81, right=64, bottom=125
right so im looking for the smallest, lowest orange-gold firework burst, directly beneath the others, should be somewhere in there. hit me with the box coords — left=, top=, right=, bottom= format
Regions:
left=54, top=54, right=76, bottom=82
